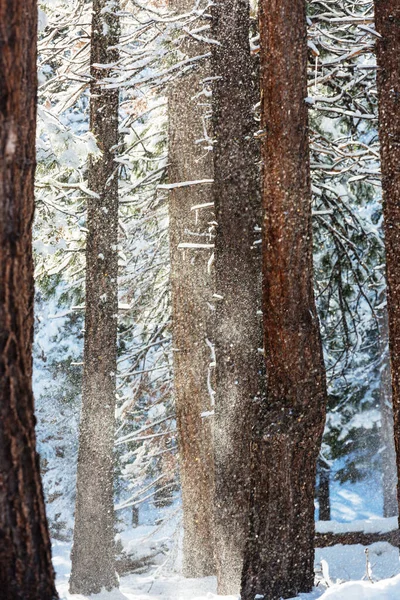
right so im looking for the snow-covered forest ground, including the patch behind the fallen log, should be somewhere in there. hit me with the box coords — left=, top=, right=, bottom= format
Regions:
left=49, top=479, right=400, bottom=600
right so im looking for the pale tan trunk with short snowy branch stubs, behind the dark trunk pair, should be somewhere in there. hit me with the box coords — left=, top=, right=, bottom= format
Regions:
left=168, top=0, right=215, bottom=577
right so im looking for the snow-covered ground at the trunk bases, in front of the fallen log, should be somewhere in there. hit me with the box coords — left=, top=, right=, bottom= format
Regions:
left=53, top=541, right=400, bottom=600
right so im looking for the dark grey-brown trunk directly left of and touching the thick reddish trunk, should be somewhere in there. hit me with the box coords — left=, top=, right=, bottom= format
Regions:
left=213, top=0, right=263, bottom=594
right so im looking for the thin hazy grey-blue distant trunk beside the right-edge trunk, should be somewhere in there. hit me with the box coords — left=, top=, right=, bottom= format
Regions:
left=378, top=307, right=398, bottom=517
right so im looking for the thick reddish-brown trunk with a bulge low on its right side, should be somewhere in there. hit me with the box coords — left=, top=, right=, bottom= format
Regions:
left=242, top=0, right=327, bottom=600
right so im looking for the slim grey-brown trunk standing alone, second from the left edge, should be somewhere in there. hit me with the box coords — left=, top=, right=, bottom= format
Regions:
left=70, top=0, right=119, bottom=594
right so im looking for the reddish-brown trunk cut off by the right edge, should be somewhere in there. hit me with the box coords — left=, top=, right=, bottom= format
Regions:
left=375, top=0, right=400, bottom=524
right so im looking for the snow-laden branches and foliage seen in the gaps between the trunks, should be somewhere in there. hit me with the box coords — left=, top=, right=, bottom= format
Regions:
left=34, top=1, right=393, bottom=535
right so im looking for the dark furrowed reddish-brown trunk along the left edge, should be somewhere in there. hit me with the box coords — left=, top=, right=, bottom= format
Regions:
left=0, top=0, right=58, bottom=600
